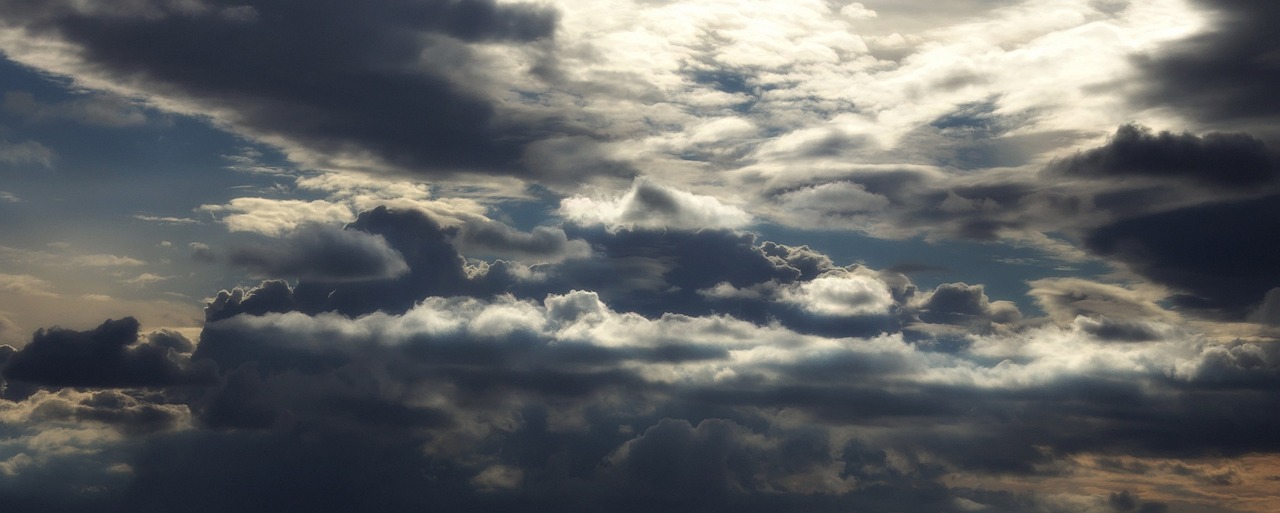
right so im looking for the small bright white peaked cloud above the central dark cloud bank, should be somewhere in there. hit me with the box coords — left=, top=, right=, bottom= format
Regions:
left=559, top=180, right=751, bottom=229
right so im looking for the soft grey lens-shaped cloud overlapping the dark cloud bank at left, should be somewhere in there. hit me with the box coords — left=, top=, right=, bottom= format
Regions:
left=227, top=224, right=408, bottom=281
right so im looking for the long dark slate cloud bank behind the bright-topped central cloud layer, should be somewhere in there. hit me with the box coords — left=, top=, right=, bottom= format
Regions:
left=217, top=209, right=910, bottom=334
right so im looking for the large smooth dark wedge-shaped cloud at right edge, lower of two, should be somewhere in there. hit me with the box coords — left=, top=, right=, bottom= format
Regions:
left=1084, top=196, right=1280, bottom=317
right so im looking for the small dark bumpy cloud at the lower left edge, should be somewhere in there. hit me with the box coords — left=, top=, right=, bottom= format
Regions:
left=0, top=317, right=210, bottom=388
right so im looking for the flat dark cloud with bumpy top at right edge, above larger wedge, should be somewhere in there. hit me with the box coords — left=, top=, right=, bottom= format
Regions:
left=1048, top=124, right=1280, bottom=188
